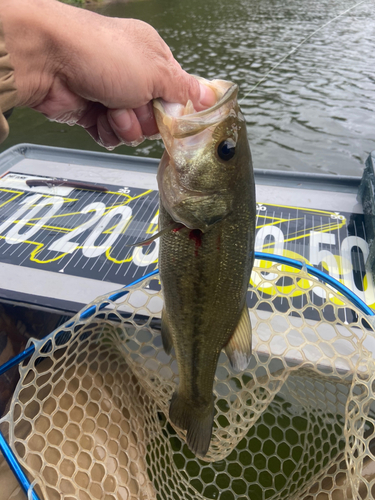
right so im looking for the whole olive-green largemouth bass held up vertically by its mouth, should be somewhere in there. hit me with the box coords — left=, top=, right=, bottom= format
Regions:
left=154, top=80, right=255, bottom=456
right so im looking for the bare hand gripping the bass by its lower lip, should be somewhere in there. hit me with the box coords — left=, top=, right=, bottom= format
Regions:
left=0, top=0, right=215, bottom=148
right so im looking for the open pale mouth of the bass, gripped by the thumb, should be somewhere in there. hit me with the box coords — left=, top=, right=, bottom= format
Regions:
left=153, top=76, right=238, bottom=139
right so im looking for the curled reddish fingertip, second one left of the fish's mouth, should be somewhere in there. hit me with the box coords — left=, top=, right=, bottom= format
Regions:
left=107, top=109, right=144, bottom=146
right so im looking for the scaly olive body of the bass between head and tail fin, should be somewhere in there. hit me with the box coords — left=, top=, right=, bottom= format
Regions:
left=159, top=203, right=254, bottom=382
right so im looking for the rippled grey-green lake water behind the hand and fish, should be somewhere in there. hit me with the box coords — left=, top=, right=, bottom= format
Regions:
left=1, top=0, right=375, bottom=176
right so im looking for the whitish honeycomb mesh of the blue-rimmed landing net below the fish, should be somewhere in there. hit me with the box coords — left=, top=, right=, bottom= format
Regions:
left=1, top=265, right=375, bottom=500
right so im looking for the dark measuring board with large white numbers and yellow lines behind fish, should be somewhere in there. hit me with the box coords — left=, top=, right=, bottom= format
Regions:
left=0, top=145, right=375, bottom=313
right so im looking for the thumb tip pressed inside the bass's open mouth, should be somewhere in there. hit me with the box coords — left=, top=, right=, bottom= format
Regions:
left=160, top=65, right=217, bottom=111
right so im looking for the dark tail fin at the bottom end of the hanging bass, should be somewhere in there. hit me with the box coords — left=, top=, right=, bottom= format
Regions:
left=169, top=392, right=214, bottom=457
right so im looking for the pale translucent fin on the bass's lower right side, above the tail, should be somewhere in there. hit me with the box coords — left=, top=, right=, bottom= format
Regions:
left=224, top=304, right=252, bottom=372
